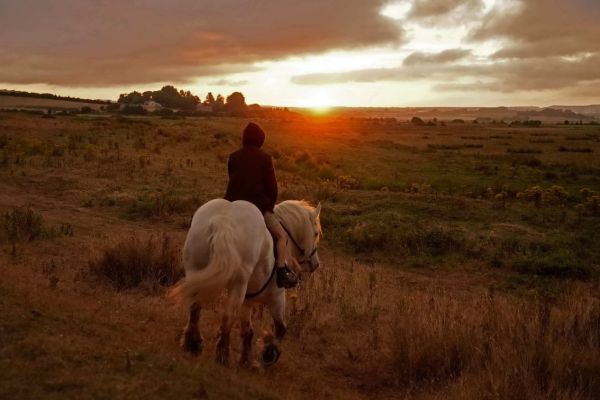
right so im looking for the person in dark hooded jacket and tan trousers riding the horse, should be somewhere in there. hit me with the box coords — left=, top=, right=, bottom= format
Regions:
left=225, top=122, right=298, bottom=289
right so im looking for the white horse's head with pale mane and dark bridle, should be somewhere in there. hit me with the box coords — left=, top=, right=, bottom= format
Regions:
left=275, top=200, right=322, bottom=272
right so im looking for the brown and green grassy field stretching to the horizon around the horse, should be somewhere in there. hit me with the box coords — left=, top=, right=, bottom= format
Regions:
left=0, top=111, right=600, bottom=399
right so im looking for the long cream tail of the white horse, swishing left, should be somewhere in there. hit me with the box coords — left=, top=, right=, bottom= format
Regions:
left=168, top=214, right=242, bottom=304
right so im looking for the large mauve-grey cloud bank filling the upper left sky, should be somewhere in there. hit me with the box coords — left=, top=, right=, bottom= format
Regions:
left=0, top=0, right=402, bottom=86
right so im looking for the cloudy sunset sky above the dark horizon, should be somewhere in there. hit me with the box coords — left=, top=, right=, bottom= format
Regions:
left=0, top=0, right=600, bottom=107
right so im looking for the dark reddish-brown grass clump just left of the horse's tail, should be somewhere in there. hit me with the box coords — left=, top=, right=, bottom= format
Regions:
left=89, top=235, right=183, bottom=290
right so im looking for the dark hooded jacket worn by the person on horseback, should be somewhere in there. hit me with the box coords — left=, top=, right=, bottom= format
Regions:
left=225, top=123, right=277, bottom=214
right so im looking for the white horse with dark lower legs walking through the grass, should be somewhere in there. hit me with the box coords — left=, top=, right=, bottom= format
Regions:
left=171, top=199, right=321, bottom=366
